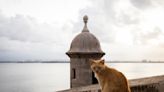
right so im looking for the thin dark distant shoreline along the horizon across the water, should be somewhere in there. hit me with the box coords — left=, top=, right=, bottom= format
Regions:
left=0, top=61, right=164, bottom=63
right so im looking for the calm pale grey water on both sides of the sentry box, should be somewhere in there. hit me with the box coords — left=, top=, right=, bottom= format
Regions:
left=0, top=63, right=164, bottom=92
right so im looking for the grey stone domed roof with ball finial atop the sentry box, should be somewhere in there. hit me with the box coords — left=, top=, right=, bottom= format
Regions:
left=67, top=16, right=104, bottom=54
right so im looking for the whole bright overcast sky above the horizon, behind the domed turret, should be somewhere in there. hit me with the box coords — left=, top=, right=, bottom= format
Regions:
left=0, top=0, right=164, bottom=61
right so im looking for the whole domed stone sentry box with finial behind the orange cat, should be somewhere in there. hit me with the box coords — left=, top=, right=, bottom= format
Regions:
left=66, top=16, right=105, bottom=88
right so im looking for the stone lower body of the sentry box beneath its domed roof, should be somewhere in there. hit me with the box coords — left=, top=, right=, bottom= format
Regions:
left=70, top=53, right=102, bottom=88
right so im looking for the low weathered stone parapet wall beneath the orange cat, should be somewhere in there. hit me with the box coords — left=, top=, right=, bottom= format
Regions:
left=59, top=75, right=164, bottom=92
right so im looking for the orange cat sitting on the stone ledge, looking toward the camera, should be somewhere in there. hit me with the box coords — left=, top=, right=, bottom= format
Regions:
left=90, top=60, right=131, bottom=92
